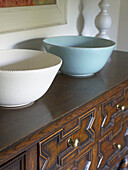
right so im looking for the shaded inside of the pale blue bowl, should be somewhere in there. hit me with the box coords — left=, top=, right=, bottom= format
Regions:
left=44, top=36, right=115, bottom=48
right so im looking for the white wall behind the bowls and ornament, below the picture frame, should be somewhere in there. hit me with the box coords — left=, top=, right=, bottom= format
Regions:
left=0, top=0, right=127, bottom=49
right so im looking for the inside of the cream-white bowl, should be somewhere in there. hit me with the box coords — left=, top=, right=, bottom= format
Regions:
left=0, top=49, right=61, bottom=71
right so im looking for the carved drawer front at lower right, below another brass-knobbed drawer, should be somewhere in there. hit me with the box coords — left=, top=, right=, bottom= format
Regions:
left=97, top=115, right=128, bottom=169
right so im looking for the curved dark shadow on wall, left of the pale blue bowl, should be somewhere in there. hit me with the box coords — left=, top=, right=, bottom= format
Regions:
left=12, top=38, right=45, bottom=51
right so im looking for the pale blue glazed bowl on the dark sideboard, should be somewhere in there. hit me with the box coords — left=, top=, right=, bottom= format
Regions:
left=43, top=36, right=115, bottom=77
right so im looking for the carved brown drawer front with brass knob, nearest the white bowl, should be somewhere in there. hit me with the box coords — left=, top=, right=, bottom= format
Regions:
left=39, top=108, right=96, bottom=170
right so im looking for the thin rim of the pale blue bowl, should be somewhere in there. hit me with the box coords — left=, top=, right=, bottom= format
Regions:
left=43, top=35, right=116, bottom=50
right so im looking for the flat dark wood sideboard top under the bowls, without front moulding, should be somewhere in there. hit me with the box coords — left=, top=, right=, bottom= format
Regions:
left=0, top=51, right=128, bottom=151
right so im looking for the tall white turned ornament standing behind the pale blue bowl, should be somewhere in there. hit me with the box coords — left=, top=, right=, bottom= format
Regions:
left=95, top=0, right=112, bottom=39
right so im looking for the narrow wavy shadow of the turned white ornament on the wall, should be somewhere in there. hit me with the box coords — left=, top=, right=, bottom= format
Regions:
left=76, top=0, right=85, bottom=35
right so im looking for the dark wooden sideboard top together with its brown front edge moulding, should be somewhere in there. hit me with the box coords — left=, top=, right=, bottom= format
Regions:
left=0, top=51, right=128, bottom=166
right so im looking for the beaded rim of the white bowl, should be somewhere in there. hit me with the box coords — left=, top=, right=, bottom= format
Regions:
left=0, top=49, right=62, bottom=73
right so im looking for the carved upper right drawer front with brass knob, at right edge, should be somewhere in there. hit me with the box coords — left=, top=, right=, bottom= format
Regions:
left=101, top=88, right=128, bottom=135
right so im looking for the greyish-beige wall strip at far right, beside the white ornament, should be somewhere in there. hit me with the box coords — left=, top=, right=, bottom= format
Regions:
left=117, top=0, right=128, bottom=51
